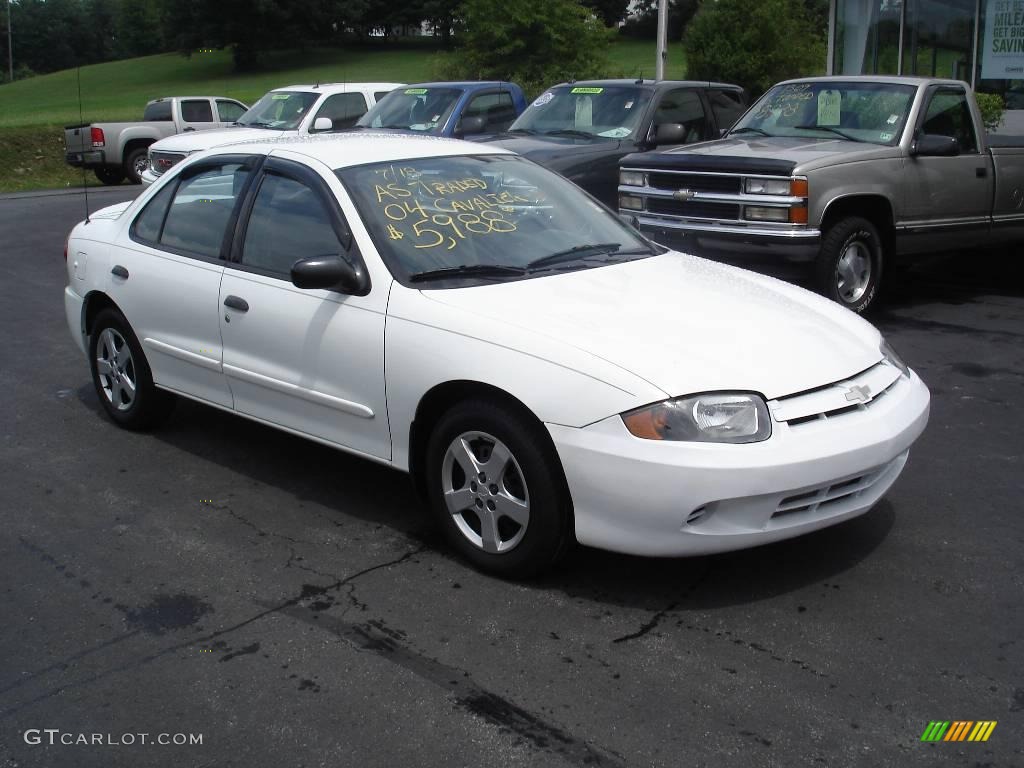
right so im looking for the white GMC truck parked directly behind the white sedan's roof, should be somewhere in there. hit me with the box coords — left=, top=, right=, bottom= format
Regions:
left=142, top=83, right=404, bottom=184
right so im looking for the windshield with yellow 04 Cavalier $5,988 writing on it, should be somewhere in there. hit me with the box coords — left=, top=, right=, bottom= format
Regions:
left=337, top=155, right=656, bottom=288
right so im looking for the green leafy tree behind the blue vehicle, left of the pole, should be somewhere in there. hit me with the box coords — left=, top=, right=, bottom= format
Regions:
left=442, top=0, right=608, bottom=92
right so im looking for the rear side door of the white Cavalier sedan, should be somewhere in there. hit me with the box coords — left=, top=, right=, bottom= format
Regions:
left=108, top=156, right=260, bottom=408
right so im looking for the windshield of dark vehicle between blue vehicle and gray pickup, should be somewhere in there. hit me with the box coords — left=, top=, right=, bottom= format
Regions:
left=509, top=85, right=650, bottom=138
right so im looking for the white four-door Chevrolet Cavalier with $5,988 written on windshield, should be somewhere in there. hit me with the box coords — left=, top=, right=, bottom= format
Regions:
left=65, top=134, right=929, bottom=575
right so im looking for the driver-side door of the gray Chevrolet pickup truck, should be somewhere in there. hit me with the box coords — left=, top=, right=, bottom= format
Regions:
left=900, top=85, right=993, bottom=250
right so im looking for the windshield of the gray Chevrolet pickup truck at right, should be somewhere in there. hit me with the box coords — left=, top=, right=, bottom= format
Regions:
left=730, top=80, right=914, bottom=146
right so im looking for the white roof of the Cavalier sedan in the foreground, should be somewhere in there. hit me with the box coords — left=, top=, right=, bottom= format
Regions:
left=203, top=130, right=514, bottom=169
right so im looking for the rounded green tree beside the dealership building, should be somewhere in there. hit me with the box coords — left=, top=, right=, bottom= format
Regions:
left=683, top=0, right=825, bottom=96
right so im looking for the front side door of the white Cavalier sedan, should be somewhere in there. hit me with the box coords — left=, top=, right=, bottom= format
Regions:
left=220, top=157, right=391, bottom=460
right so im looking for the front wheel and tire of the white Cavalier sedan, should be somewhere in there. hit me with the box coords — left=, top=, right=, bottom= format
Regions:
left=424, top=400, right=572, bottom=579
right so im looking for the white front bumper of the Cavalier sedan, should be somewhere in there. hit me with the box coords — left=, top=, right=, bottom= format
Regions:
left=548, top=374, right=930, bottom=556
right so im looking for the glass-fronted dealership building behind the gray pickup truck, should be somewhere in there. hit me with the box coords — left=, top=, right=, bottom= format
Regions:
left=828, top=0, right=1024, bottom=134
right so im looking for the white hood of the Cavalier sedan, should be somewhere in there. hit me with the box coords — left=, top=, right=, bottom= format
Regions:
left=424, top=252, right=882, bottom=399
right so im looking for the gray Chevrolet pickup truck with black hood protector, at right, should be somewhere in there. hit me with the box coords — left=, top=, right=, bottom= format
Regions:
left=618, top=76, right=1024, bottom=312
